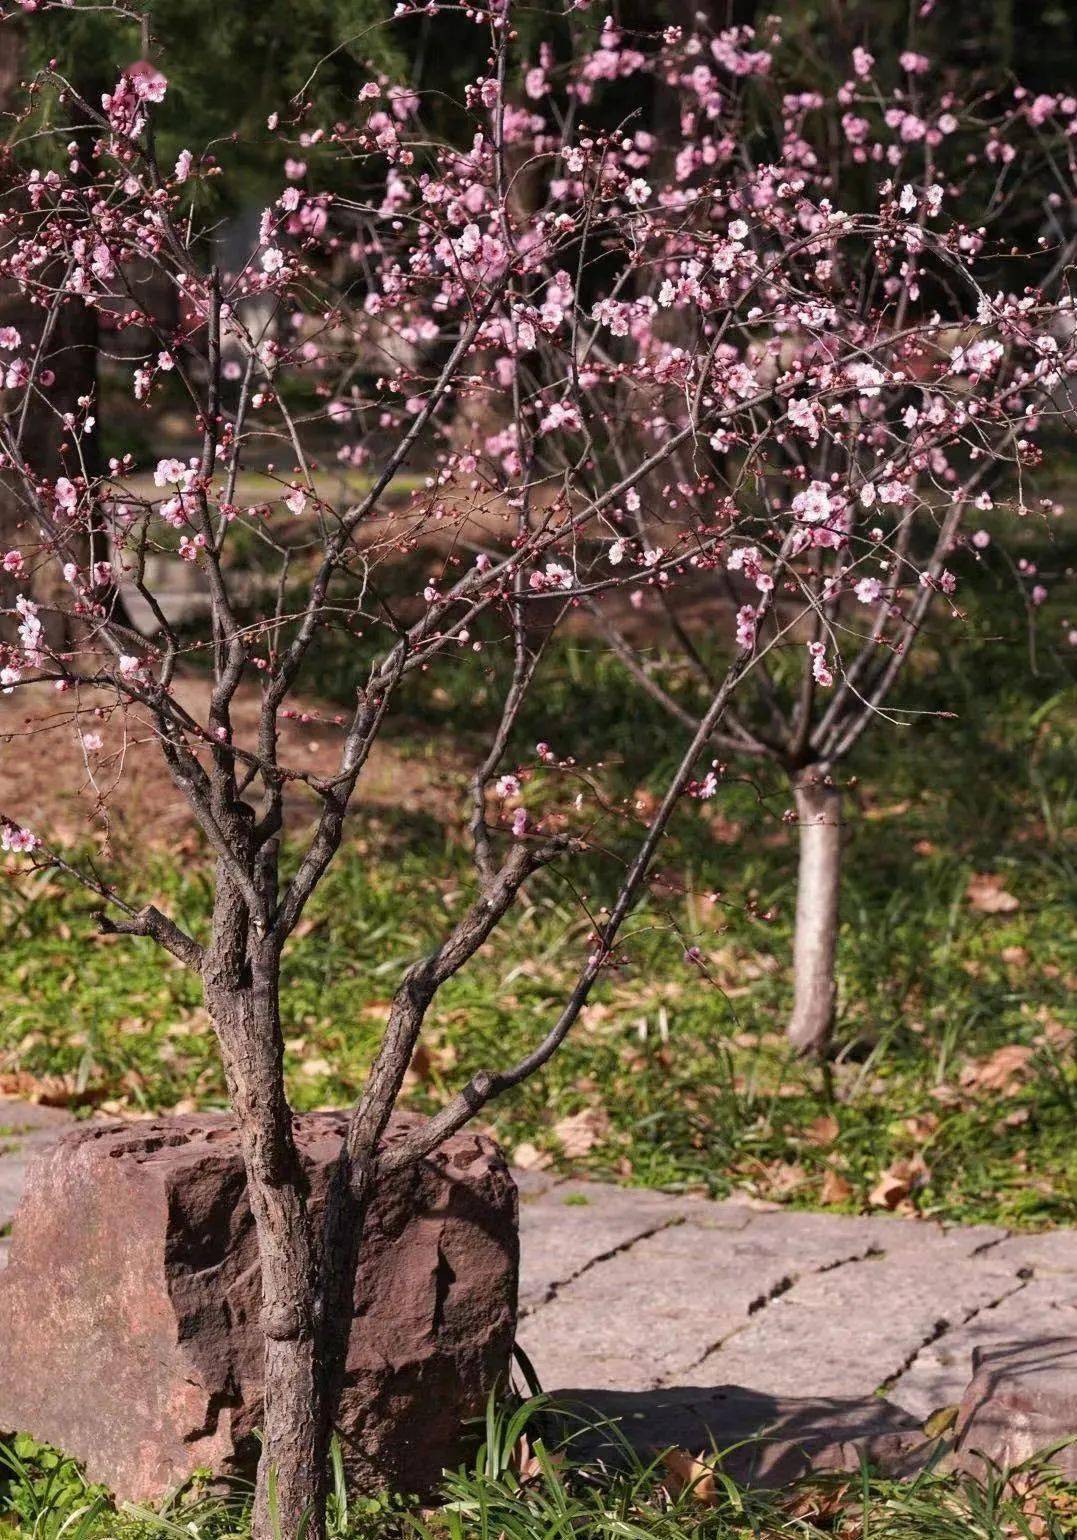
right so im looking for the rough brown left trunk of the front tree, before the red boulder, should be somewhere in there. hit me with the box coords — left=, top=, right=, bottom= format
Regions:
left=203, top=873, right=325, bottom=1540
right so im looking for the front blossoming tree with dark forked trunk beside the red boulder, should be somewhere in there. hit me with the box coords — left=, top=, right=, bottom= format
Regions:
left=0, top=0, right=1068, bottom=1540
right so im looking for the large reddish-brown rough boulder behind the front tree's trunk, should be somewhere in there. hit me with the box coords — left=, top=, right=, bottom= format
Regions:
left=0, top=1112, right=518, bottom=1502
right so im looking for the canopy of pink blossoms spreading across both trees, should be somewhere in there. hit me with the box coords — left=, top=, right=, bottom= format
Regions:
left=0, top=6, right=1077, bottom=843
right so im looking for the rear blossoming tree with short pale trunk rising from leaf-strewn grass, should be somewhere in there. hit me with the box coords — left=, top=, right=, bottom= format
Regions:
left=593, top=18, right=1074, bottom=1053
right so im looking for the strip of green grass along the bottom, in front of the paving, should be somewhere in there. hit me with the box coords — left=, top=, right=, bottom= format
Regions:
left=0, top=1398, right=1077, bottom=1540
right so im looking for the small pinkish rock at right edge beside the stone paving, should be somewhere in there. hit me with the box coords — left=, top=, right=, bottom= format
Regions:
left=957, top=1337, right=1077, bottom=1481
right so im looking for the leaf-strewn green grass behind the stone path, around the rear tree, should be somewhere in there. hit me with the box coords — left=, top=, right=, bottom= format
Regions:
left=0, top=511, right=1077, bottom=1227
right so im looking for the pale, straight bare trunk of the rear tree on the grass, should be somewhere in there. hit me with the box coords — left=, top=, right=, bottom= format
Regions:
left=789, top=765, right=841, bottom=1053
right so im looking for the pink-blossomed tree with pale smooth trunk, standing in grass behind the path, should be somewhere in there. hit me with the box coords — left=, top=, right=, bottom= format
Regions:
left=563, top=29, right=1077, bottom=1053
